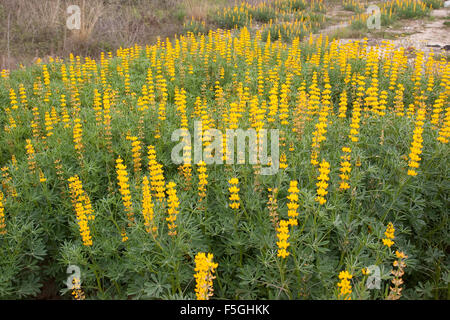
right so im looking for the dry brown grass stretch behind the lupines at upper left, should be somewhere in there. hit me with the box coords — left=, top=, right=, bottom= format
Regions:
left=0, top=0, right=235, bottom=69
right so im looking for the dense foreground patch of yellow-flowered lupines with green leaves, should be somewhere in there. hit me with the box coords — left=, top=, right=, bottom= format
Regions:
left=0, top=1, right=450, bottom=299
